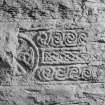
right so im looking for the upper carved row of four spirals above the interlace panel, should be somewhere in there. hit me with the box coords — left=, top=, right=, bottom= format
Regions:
left=35, top=30, right=89, bottom=48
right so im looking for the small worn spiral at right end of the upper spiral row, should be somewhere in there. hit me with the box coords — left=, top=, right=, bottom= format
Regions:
left=77, top=32, right=88, bottom=45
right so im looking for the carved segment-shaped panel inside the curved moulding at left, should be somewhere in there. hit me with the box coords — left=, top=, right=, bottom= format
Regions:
left=17, top=36, right=38, bottom=72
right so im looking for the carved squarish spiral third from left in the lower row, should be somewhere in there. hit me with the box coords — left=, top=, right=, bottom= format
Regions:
left=68, top=67, right=80, bottom=80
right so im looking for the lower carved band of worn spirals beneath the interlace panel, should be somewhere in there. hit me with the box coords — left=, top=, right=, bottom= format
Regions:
left=35, top=66, right=105, bottom=83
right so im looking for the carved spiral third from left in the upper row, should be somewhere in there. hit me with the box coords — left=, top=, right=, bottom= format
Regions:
left=65, top=32, right=77, bottom=46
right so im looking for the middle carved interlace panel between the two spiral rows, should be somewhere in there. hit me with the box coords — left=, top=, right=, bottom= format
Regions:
left=40, top=49, right=92, bottom=65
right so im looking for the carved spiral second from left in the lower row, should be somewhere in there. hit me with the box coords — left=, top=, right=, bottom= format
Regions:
left=55, top=68, right=68, bottom=81
